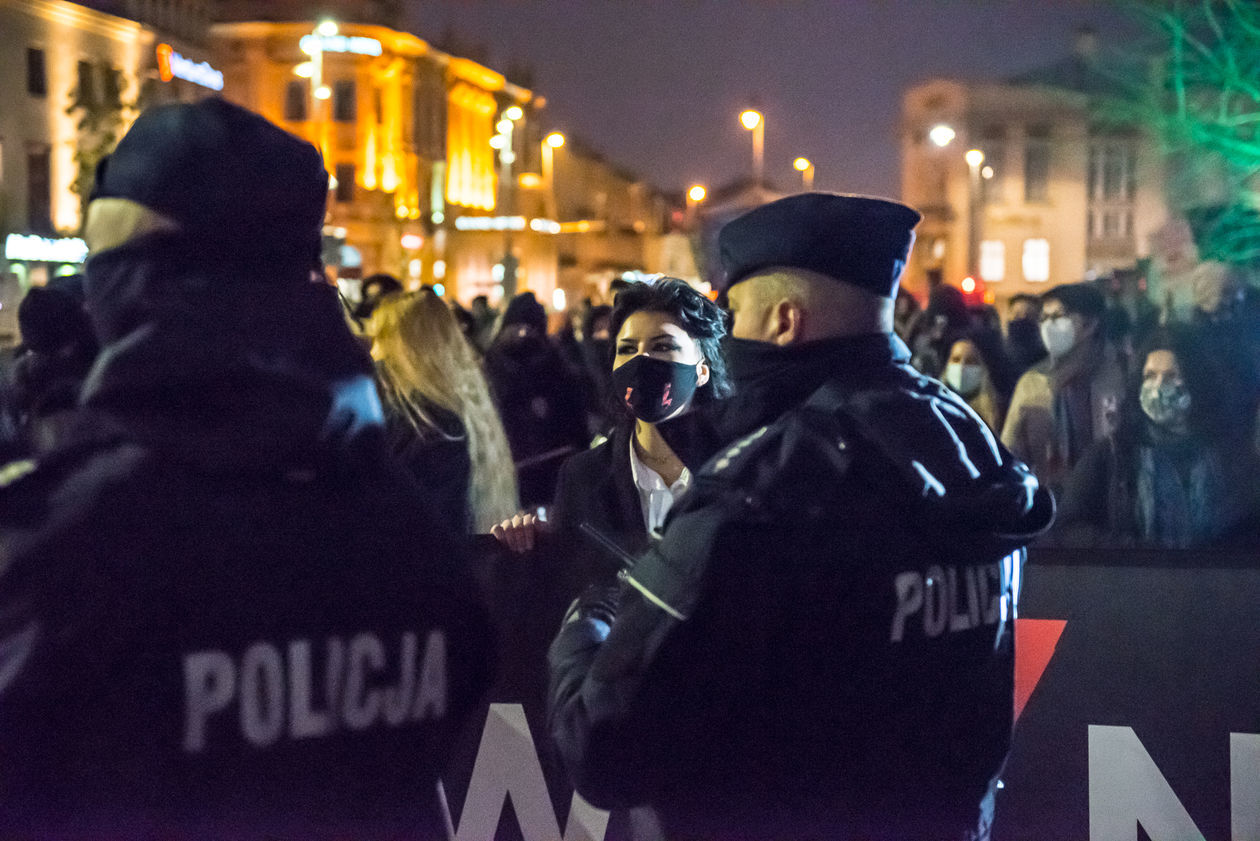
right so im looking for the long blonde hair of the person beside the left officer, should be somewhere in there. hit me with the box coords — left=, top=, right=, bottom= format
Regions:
left=372, top=290, right=517, bottom=532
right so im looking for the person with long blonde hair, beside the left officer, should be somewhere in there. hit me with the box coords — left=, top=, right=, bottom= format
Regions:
left=372, top=289, right=517, bottom=533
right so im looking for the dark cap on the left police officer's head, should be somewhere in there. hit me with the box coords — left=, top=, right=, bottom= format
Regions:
left=91, top=98, right=328, bottom=266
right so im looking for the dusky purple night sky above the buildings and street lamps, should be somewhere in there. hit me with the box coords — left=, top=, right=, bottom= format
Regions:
left=411, top=0, right=1139, bottom=197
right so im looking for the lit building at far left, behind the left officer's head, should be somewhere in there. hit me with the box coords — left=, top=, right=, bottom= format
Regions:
left=0, top=0, right=214, bottom=345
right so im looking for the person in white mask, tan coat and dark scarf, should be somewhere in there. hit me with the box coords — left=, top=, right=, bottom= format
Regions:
left=1002, top=282, right=1124, bottom=489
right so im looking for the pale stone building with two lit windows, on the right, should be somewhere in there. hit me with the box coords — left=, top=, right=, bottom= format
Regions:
left=901, top=33, right=1168, bottom=301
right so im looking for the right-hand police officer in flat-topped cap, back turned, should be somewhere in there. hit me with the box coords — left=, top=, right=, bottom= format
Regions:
left=551, top=193, right=1053, bottom=841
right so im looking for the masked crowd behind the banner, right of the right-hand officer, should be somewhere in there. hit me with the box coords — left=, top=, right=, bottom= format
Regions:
left=897, top=266, right=1260, bottom=550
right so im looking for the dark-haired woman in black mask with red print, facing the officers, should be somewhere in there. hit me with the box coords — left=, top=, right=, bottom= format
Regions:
left=494, top=277, right=730, bottom=572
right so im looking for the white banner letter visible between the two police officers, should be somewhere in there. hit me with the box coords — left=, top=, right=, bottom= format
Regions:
left=455, top=704, right=609, bottom=841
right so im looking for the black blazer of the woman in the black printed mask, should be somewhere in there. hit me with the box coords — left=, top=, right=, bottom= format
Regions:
left=551, top=425, right=648, bottom=595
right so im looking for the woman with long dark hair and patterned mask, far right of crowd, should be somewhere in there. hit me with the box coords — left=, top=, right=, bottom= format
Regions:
left=1055, top=328, right=1260, bottom=548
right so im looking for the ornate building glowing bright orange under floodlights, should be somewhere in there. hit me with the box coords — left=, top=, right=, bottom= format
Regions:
left=212, top=16, right=556, bottom=301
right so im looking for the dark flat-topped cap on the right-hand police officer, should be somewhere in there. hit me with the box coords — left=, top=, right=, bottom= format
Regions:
left=718, top=193, right=922, bottom=298
